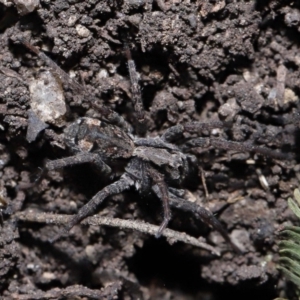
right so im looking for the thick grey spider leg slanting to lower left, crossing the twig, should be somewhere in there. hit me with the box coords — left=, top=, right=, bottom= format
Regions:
left=66, top=174, right=134, bottom=231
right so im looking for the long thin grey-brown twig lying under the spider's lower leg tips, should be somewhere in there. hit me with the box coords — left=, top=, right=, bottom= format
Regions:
left=15, top=211, right=220, bottom=256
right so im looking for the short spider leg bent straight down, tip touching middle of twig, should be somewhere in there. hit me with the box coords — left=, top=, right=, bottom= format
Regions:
left=148, top=167, right=171, bottom=238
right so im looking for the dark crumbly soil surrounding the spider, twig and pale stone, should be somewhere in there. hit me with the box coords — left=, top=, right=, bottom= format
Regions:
left=0, top=0, right=300, bottom=300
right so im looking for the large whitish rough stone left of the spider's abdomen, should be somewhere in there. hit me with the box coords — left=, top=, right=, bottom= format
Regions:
left=29, top=71, right=67, bottom=126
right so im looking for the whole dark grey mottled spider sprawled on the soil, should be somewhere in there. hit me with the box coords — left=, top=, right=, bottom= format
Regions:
left=21, top=39, right=284, bottom=251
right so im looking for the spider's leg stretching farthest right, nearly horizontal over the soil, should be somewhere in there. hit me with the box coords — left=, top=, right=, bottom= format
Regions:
left=183, top=138, right=290, bottom=159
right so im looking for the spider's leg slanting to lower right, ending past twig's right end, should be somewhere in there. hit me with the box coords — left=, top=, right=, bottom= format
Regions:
left=169, top=192, right=241, bottom=253
